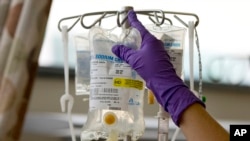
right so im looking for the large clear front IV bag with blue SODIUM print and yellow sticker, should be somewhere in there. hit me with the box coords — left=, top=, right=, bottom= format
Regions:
left=81, top=27, right=145, bottom=141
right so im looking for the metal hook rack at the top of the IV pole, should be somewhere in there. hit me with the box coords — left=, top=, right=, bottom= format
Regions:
left=58, top=6, right=199, bottom=32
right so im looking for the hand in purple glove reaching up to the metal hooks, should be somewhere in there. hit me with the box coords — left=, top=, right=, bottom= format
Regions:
left=112, top=11, right=205, bottom=126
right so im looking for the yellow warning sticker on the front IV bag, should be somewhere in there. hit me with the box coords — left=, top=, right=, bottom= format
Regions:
left=113, top=78, right=143, bottom=90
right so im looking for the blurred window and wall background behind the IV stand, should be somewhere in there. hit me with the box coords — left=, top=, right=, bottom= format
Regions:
left=0, top=0, right=250, bottom=141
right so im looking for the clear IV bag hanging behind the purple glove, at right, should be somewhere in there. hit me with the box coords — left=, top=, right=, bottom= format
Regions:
left=146, top=24, right=186, bottom=77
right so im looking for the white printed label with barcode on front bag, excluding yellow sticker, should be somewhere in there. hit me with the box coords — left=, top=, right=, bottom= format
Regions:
left=90, top=59, right=131, bottom=110
